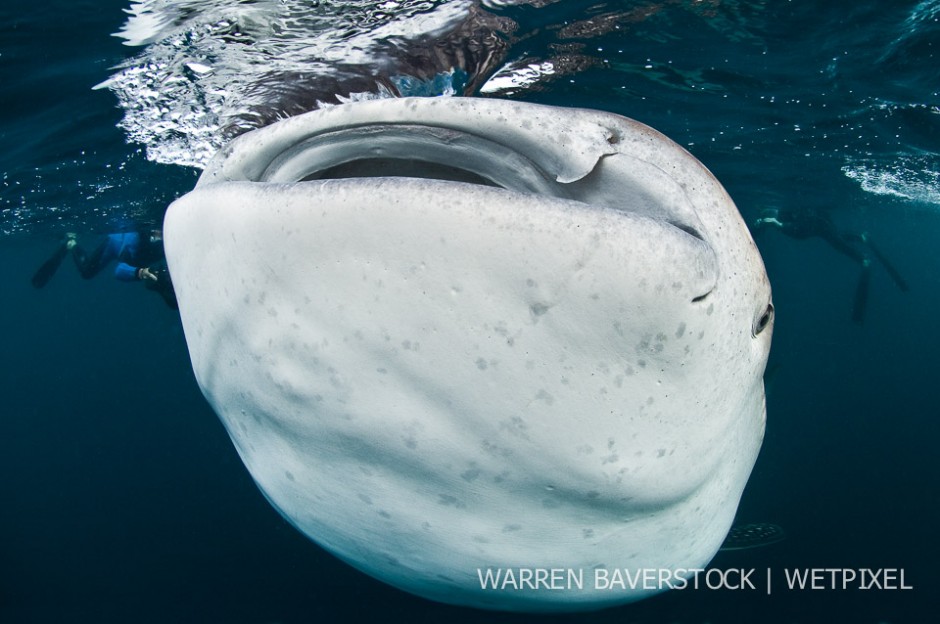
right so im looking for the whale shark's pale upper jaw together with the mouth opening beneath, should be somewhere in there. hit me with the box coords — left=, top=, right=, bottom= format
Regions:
left=199, top=98, right=703, bottom=245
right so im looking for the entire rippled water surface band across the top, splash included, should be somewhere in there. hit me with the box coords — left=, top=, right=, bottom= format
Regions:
left=0, top=0, right=940, bottom=234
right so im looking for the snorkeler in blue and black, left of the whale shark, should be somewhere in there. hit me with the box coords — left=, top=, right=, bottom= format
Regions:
left=32, top=230, right=179, bottom=310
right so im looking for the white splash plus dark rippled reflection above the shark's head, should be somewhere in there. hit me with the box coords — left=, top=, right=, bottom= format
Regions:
left=99, top=0, right=776, bottom=168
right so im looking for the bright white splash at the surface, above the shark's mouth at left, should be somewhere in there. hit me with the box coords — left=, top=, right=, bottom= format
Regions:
left=97, top=0, right=482, bottom=168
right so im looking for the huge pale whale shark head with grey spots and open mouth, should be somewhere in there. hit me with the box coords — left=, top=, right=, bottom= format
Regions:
left=164, top=98, right=773, bottom=611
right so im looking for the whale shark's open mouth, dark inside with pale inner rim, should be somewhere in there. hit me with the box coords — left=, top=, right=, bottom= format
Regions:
left=209, top=108, right=707, bottom=255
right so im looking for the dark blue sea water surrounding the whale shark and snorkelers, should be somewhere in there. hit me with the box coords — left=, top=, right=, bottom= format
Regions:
left=0, top=0, right=940, bottom=623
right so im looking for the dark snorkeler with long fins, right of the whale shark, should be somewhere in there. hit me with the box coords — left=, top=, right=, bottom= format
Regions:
left=754, top=208, right=908, bottom=323
